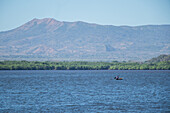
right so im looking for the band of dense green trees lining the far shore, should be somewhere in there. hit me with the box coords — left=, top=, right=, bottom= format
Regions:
left=0, top=61, right=170, bottom=70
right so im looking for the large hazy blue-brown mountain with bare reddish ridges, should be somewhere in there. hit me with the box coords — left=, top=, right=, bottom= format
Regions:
left=0, top=18, right=170, bottom=61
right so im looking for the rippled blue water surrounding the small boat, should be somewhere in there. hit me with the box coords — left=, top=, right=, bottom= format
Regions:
left=0, top=70, right=170, bottom=113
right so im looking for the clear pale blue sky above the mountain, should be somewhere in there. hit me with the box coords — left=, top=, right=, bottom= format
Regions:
left=0, top=0, right=170, bottom=31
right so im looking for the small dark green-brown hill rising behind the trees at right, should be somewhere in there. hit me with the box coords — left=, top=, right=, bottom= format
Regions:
left=147, top=55, right=170, bottom=62
